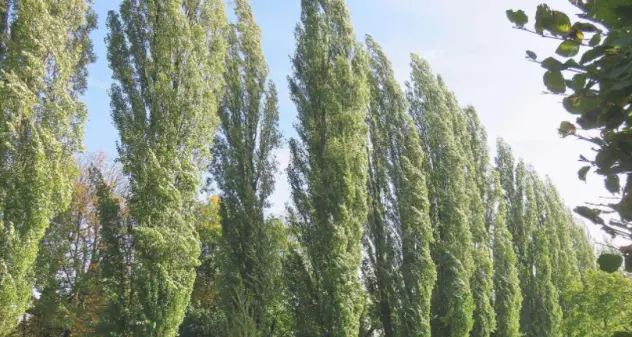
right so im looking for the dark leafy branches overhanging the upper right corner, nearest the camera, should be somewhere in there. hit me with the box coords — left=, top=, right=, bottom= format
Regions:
left=507, top=0, right=632, bottom=236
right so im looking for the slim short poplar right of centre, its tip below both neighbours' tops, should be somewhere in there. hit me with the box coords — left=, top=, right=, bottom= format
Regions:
left=492, top=174, right=522, bottom=337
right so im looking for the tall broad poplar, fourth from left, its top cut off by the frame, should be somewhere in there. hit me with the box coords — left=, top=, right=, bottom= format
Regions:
left=286, top=0, right=368, bottom=337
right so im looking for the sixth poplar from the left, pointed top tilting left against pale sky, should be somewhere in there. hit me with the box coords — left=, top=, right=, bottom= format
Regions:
left=406, top=54, right=474, bottom=337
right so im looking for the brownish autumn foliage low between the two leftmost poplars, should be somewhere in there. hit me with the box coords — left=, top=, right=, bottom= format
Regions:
left=8, top=153, right=124, bottom=336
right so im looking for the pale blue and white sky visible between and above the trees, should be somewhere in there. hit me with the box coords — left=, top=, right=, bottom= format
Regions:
left=85, top=0, right=608, bottom=242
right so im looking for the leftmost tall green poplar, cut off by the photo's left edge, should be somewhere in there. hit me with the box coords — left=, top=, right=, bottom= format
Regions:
left=0, top=0, right=96, bottom=330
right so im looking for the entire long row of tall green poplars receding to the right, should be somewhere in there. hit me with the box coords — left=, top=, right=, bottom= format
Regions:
left=0, top=0, right=594, bottom=337
